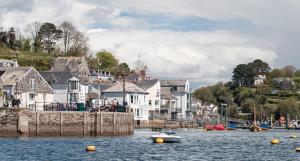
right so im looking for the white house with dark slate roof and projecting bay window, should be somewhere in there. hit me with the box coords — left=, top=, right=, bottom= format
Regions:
left=40, top=72, right=89, bottom=104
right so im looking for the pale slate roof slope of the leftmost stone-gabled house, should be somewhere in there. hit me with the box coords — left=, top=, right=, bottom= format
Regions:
left=0, top=67, right=32, bottom=85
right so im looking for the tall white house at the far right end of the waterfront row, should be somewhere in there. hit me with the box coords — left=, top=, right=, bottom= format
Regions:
left=160, top=80, right=192, bottom=120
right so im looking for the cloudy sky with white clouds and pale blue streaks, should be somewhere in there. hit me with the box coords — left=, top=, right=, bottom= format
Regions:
left=0, top=0, right=300, bottom=87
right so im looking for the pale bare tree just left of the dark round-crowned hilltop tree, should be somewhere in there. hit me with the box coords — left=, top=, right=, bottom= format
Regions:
left=25, top=22, right=41, bottom=52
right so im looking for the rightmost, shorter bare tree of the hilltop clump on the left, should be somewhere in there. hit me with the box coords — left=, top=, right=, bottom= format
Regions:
left=69, top=31, right=88, bottom=56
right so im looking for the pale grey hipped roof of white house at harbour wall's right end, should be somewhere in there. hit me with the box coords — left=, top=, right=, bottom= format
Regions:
left=103, top=82, right=147, bottom=94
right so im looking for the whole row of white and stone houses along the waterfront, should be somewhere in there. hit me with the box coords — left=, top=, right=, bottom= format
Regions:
left=0, top=57, right=192, bottom=123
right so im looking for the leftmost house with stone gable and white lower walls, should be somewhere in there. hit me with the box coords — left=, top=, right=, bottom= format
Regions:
left=0, top=67, right=53, bottom=110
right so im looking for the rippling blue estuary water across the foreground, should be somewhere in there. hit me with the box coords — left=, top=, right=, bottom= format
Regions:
left=0, top=129, right=300, bottom=161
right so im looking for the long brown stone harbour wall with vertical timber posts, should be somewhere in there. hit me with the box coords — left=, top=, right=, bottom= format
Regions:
left=0, top=111, right=134, bottom=136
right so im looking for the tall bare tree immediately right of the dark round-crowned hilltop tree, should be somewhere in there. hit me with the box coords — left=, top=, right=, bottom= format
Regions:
left=60, top=21, right=76, bottom=55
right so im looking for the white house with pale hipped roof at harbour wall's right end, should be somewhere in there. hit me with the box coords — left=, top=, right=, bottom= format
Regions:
left=102, top=82, right=149, bottom=125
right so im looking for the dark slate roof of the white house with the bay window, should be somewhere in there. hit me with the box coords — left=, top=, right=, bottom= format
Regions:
left=40, top=72, right=73, bottom=84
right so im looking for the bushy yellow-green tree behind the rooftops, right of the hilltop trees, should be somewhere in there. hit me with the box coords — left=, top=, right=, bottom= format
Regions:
left=96, top=50, right=118, bottom=71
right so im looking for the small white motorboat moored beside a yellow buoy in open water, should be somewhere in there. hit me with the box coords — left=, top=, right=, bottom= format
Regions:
left=151, top=133, right=181, bottom=143
